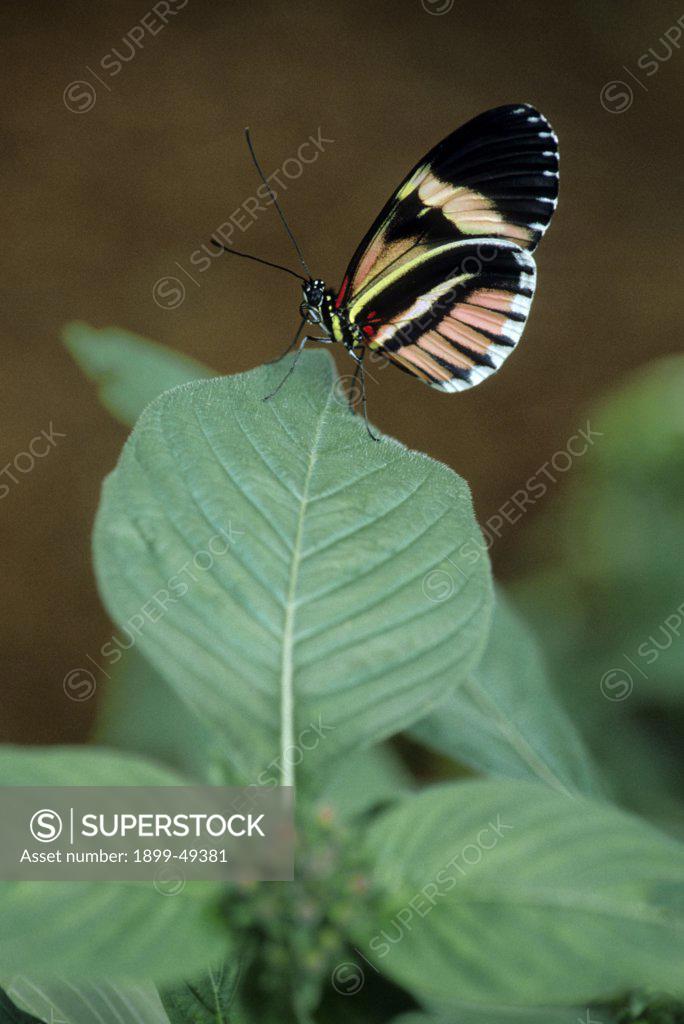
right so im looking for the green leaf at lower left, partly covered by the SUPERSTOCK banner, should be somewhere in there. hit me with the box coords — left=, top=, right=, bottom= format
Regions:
left=0, top=746, right=228, bottom=980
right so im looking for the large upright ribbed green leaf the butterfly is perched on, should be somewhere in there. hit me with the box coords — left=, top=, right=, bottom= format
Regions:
left=95, top=351, right=491, bottom=784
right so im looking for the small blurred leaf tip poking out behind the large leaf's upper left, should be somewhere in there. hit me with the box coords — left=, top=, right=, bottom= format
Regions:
left=62, top=323, right=215, bottom=427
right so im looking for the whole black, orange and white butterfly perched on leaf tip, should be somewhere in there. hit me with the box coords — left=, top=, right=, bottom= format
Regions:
left=212, top=103, right=558, bottom=436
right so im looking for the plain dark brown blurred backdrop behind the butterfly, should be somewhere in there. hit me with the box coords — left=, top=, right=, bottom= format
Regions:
left=0, top=0, right=684, bottom=741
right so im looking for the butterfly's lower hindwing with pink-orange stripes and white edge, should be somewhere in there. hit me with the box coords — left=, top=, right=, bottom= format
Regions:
left=349, top=239, right=536, bottom=391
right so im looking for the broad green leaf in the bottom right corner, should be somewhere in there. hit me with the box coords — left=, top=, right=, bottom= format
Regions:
left=357, top=779, right=684, bottom=1006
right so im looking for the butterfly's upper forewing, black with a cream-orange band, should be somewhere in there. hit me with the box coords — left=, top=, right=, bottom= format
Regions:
left=338, top=103, right=558, bottom=304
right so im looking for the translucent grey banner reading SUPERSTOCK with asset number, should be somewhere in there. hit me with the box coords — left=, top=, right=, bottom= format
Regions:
left=0, top=785, right=294, bottom=891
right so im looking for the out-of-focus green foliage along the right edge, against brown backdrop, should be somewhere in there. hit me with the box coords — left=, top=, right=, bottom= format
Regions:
left=513, top=356, right=684, bottom=834
